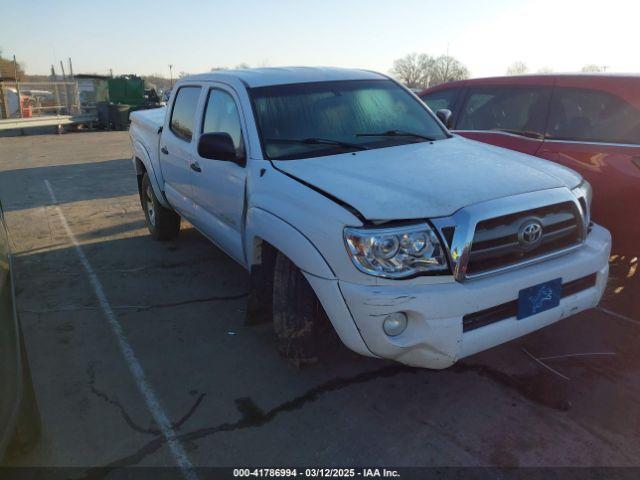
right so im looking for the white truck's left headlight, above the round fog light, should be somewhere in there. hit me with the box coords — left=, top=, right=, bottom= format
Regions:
left=344, top=224, right=449, bottom=278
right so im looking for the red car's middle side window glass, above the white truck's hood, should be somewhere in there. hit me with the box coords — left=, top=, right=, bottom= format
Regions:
left=456, top=87, right=551, bottom=138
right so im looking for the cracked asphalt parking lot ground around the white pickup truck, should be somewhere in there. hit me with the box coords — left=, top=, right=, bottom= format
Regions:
left=0, top=132, right=640, bottom=468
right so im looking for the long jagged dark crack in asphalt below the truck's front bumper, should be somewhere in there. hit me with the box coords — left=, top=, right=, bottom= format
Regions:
left=79, top=364, right=422, bottom=480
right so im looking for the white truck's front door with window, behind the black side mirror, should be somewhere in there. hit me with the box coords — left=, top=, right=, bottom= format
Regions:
left=191, top=87, right=247, bottom=264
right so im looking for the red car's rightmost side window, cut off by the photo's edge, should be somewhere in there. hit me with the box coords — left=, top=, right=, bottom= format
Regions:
left=547, top=88, right=640, bottom=144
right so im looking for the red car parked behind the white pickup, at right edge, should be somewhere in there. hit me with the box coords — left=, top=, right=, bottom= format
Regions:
left=419, top=75, right=640, bottom=255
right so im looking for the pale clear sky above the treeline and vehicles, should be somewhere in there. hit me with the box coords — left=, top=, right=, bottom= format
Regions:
left=0, top=0, right=640, bottom=77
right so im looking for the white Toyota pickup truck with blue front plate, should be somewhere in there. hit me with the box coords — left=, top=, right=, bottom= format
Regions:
left=130, top=67, right=611, bottom=368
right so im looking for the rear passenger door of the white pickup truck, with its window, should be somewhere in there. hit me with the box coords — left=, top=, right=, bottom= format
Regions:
left=159, top=85, right=202, bottom=214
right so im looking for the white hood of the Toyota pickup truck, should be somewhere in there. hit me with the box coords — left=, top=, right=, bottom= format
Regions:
left=273, top=136, right=581, bottom=220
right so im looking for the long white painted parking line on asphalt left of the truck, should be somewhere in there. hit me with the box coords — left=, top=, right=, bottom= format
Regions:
left=44, top=180, right=198, bottom=480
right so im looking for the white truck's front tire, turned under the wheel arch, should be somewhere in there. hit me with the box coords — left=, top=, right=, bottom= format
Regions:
left=273, top=253, right=339, bottom=366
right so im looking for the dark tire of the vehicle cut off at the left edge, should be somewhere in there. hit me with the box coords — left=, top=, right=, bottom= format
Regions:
left=7, top=324, right=42, bottom=456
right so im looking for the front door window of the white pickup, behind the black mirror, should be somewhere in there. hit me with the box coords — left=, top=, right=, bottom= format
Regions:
left=202, top=88, right=244, bottom=158
